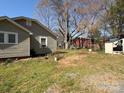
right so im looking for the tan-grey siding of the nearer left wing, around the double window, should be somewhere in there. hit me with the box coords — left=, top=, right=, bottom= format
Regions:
left=0, top=20, right=30, bottom=58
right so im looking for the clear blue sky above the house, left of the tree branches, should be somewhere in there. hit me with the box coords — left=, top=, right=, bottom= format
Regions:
left=0, top=0, right=39, bottom=17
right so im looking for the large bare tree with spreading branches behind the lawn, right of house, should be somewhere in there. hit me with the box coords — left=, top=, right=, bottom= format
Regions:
left=38, top=0, right=108, bottom=49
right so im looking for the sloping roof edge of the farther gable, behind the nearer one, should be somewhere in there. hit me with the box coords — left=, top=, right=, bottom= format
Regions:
left=12, top=16, right=57, bottom=38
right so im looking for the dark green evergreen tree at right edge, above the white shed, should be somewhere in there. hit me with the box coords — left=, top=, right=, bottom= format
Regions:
left=109, top=0, right=124, bottom=36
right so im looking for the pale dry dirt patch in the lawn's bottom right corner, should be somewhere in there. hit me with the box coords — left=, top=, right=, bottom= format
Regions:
left=81, top=73, right=124, bottom=93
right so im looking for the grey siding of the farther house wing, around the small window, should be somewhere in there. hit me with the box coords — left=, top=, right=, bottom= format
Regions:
left=16, top=20, right=57, bottom=54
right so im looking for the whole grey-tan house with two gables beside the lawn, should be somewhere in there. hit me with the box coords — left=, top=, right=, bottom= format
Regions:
left=0, top=16, right=57, bottom=58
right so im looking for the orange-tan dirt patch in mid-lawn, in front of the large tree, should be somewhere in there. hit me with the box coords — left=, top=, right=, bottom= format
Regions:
left=58, top=54, right=87, bottom=67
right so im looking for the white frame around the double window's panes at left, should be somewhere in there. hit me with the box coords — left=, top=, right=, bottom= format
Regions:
left=0, top=31, right=18, bottom=44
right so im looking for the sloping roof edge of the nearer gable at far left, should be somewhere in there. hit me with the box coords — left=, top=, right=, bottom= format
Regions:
left=0, top=16, right=32, bottom=35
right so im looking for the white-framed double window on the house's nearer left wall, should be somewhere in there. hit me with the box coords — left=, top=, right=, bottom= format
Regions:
left=0, top=31, right=18, bottom=44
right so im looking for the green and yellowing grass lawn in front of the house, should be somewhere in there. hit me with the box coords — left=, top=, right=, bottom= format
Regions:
left=0, top=50, right=124, bottom=93
